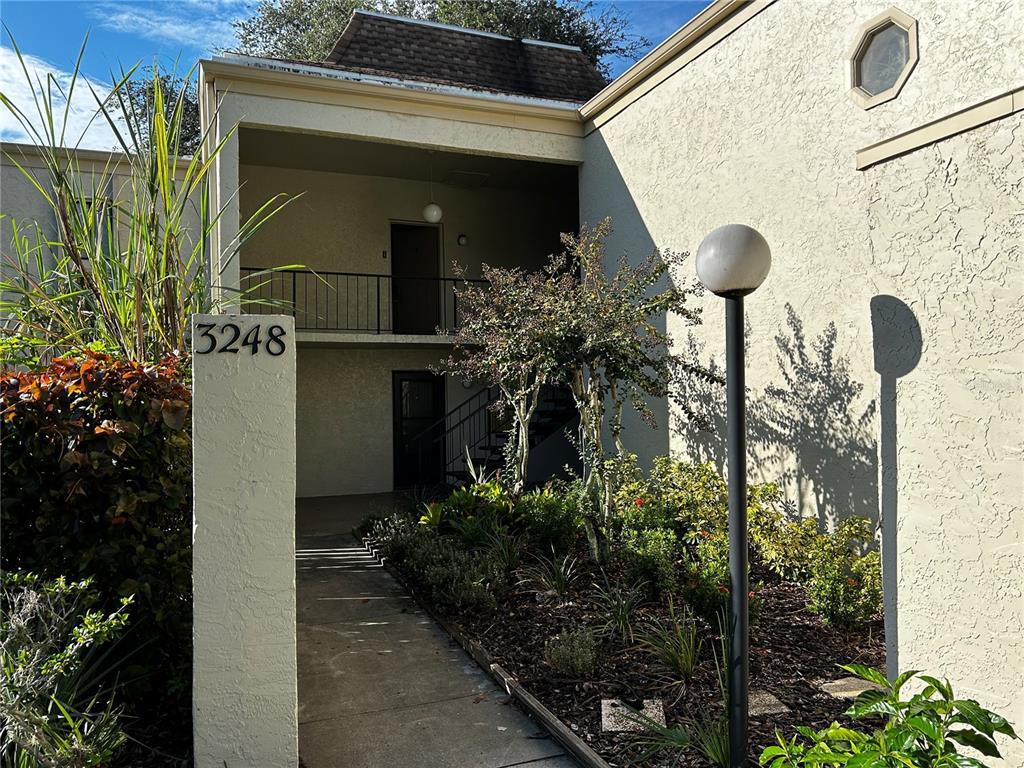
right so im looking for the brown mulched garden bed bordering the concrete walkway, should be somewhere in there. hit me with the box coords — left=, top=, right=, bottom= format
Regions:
left=362, top=475, right=885, bottom=767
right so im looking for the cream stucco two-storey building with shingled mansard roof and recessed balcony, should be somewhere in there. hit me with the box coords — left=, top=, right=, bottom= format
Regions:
left=202, top=0, right=1024, bottom=765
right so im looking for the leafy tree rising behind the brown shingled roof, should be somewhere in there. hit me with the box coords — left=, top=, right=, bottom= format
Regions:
left=234, top=0, right=649, bottom=76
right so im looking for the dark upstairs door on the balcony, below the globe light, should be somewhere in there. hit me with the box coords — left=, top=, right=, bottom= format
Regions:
left=391, top=223, right=442, bottom=334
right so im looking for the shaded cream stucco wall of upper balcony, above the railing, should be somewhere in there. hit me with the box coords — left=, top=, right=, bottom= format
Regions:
left=240, top=165, right=577, bottom=278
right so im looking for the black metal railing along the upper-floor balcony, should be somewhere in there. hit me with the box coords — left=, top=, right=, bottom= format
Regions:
left=241, top=267, right=483, bottom=335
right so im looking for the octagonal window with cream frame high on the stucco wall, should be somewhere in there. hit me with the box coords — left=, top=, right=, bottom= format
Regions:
left=849, top=8, right=918, bottom=110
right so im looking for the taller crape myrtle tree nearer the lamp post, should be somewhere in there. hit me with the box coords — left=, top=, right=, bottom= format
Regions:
left=545, top=218, right=716, bottom=560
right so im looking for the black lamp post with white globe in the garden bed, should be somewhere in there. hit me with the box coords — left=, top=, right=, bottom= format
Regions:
left=696, top=224, right=771, bottom=768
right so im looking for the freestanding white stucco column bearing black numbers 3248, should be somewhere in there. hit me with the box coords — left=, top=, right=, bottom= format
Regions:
left=193, top=314, right=298, bottom=768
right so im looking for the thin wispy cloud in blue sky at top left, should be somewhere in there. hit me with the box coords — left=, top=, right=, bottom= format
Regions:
left=89, top=0, right=245, bottom=52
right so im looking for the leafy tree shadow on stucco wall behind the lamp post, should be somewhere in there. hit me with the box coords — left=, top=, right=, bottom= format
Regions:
left=674, top=305, right=879, bottom=528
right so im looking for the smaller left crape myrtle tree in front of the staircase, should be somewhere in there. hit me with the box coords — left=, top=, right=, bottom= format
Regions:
left=438, top=264, right=555, bottom=493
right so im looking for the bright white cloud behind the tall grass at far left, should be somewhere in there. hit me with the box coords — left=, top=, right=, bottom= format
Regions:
left=0, top=45, right=118, bottom=150
